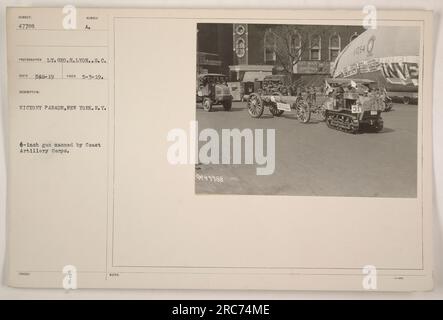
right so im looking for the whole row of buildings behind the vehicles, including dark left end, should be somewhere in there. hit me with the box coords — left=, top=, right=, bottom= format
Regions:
left=197, top=23, right=365, bottom=82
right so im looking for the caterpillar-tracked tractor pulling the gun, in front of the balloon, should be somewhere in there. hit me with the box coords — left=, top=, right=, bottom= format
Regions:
left=323, top=78, right=385, bottom=133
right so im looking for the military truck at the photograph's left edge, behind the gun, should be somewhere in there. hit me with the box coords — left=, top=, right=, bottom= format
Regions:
left=197, top=73, right=232, bottom=111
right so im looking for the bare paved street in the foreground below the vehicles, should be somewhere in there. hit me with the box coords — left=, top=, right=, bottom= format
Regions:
left=195, top=102, right=417, bottom=197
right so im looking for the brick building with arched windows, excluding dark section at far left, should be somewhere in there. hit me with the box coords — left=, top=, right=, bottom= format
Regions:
left=230, top=24, right=365, bottom=80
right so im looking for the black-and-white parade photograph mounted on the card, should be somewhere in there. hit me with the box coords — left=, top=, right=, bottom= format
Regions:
left=195, top=22, right=421, bottom=198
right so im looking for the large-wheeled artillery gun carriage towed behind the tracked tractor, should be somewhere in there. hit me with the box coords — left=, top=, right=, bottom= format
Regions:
left=247, top=75, right=311, bottom=123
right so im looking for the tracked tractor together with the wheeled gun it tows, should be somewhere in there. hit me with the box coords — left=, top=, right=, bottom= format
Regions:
left=248, top=75, right=391, bottom=133
